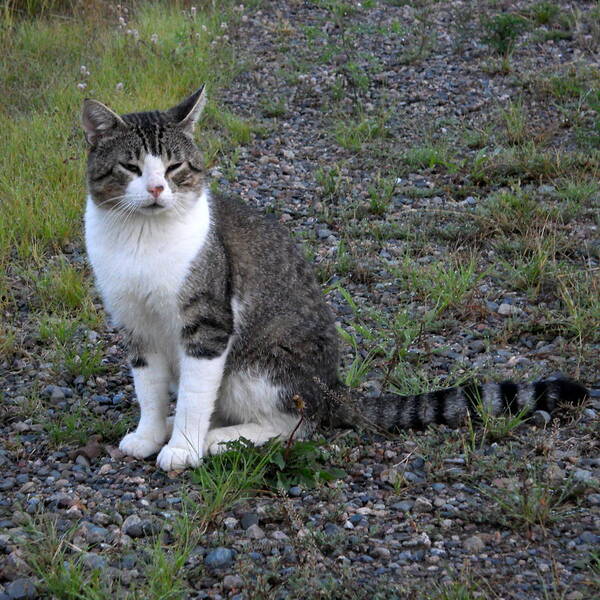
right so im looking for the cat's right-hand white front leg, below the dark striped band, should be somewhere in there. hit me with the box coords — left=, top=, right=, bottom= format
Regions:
left=156, top=349, right=227, bottom=471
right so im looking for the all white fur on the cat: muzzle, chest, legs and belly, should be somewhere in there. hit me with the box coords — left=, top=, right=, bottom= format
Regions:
left=85, top=180, right=298, bottom=470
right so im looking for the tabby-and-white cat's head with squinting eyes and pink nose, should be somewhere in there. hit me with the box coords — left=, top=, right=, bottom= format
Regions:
left=82, top=86, right=206, bottom=215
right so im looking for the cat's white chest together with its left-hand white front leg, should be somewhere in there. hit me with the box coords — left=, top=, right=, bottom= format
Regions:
left=85, top=185, right=212, bottom=466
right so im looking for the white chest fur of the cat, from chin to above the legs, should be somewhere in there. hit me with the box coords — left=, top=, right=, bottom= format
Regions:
left=85, top=190, right=210, bottom=348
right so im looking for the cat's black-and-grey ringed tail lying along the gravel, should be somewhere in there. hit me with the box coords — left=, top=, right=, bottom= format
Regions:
left=332, top=378, right=589, bottom=432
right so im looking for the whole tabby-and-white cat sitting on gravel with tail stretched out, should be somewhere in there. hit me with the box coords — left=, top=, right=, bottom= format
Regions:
left=82, top=86, right=586, bottom=470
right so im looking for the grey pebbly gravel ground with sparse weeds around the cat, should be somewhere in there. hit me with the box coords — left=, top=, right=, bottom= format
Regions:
left=0, top=0, right=600, bottom=600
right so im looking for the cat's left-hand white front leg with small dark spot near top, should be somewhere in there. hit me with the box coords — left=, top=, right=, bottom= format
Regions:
left=119, top=353, right=170, bottom=458
